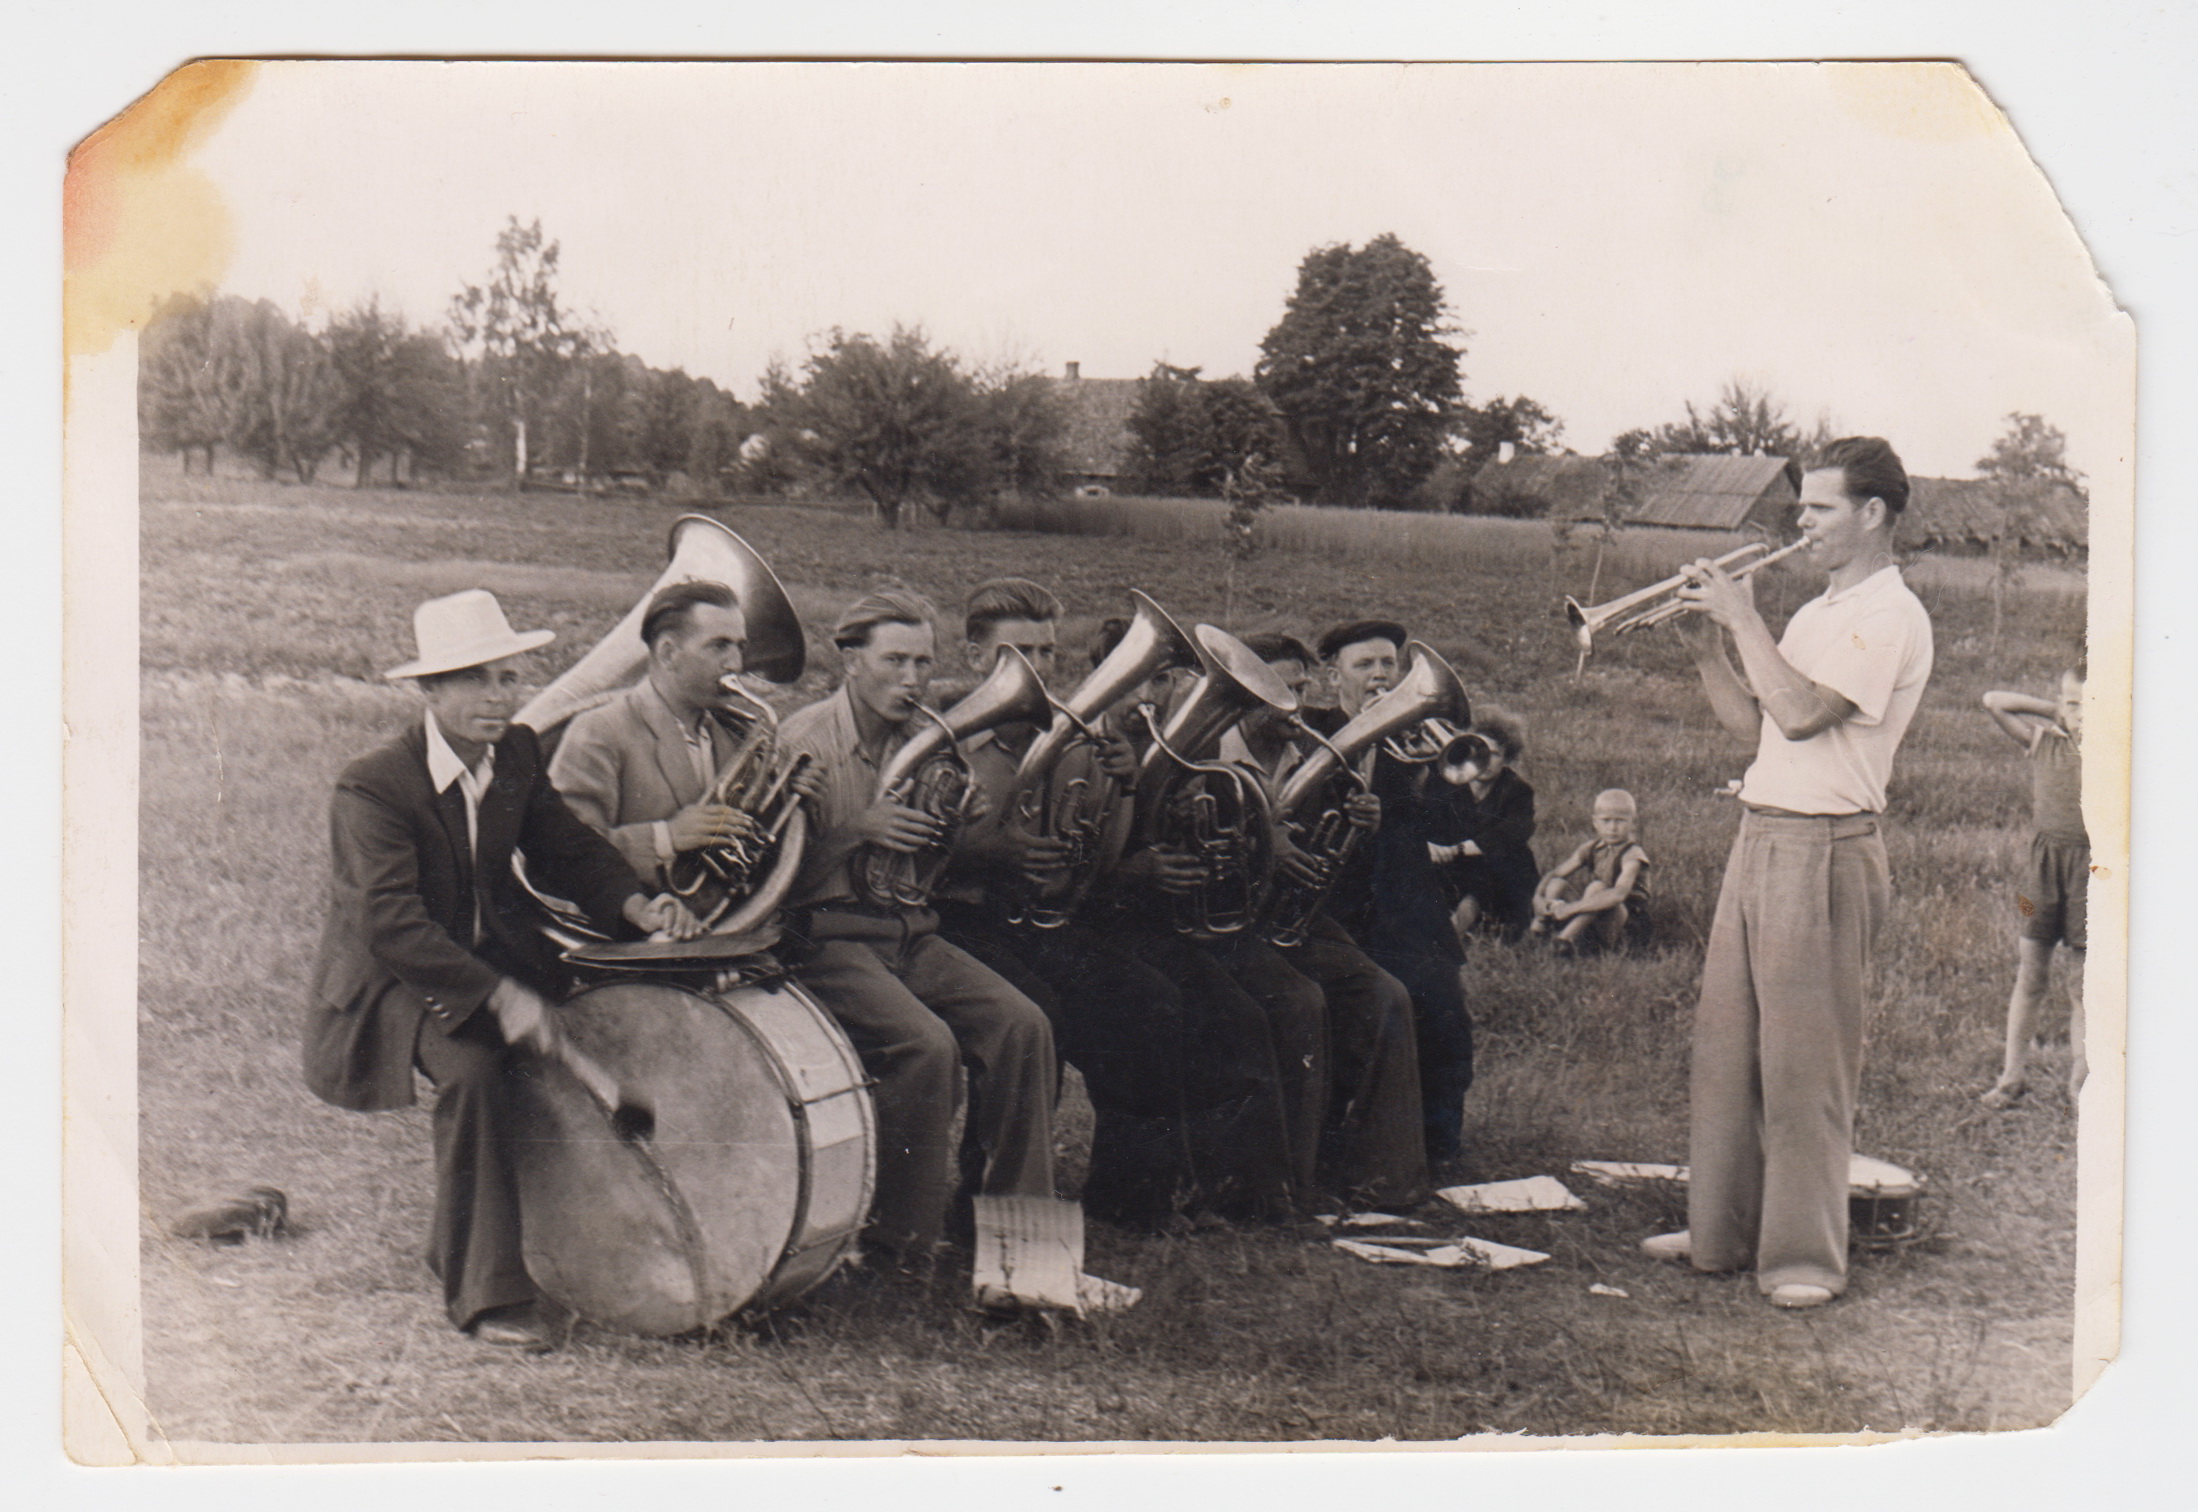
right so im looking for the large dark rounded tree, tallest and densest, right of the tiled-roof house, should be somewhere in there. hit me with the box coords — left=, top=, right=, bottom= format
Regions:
left=1255, top=235, right=1459, bottom=505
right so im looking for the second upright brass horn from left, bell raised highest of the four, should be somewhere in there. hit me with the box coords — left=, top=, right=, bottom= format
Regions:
left=1011, top=589, right=1198, bottom=930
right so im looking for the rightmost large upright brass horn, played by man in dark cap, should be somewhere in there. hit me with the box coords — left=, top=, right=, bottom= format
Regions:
left=1262, top=642, right=1488, bottom=945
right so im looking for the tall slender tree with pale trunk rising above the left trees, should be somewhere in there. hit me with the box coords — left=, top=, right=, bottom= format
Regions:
left=448, top=215, right=609, bottom=488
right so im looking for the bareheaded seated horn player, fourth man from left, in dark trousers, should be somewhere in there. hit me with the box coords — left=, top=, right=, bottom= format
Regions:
left=918, top=578, right=1196, bottom=1229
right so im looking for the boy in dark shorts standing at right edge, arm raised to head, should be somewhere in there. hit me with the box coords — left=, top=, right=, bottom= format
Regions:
left=1976, top=662, right=2090, bottom=1112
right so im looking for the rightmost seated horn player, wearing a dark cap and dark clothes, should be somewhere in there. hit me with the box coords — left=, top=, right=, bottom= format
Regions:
left=1306, top=620, right=1473, bottom=1180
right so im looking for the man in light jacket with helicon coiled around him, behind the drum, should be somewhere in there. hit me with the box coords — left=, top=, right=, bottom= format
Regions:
left=550, top=580, right=822, bottom=886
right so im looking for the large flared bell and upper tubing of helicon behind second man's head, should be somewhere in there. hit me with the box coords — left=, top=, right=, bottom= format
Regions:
left=514, top=514, right=809, bottom=734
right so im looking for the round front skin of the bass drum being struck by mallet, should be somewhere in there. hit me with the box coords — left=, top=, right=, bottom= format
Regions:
left=517, top=982, right=802, bottom=1336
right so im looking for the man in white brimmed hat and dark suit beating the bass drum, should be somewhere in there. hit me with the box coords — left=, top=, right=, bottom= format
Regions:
left=306, top=589, right=699, bottom=1352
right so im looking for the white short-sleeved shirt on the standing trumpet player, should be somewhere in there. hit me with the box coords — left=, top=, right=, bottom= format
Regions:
left=1741, top=567, right=1932, bottom=813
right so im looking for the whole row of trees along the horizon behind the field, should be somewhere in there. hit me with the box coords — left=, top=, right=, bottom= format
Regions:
left=138, top=218, right=2068, bottom=527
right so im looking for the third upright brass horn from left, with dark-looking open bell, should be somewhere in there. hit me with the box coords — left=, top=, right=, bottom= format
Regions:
left=1136, top=624, right=1297, bottom=938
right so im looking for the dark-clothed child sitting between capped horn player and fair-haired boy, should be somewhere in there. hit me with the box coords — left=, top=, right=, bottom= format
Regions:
left=1427, top=705, right=1541, bottom=941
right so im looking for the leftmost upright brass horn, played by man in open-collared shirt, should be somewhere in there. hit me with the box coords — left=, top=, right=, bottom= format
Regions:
left=848, top=646, right=1053, bottom=908
